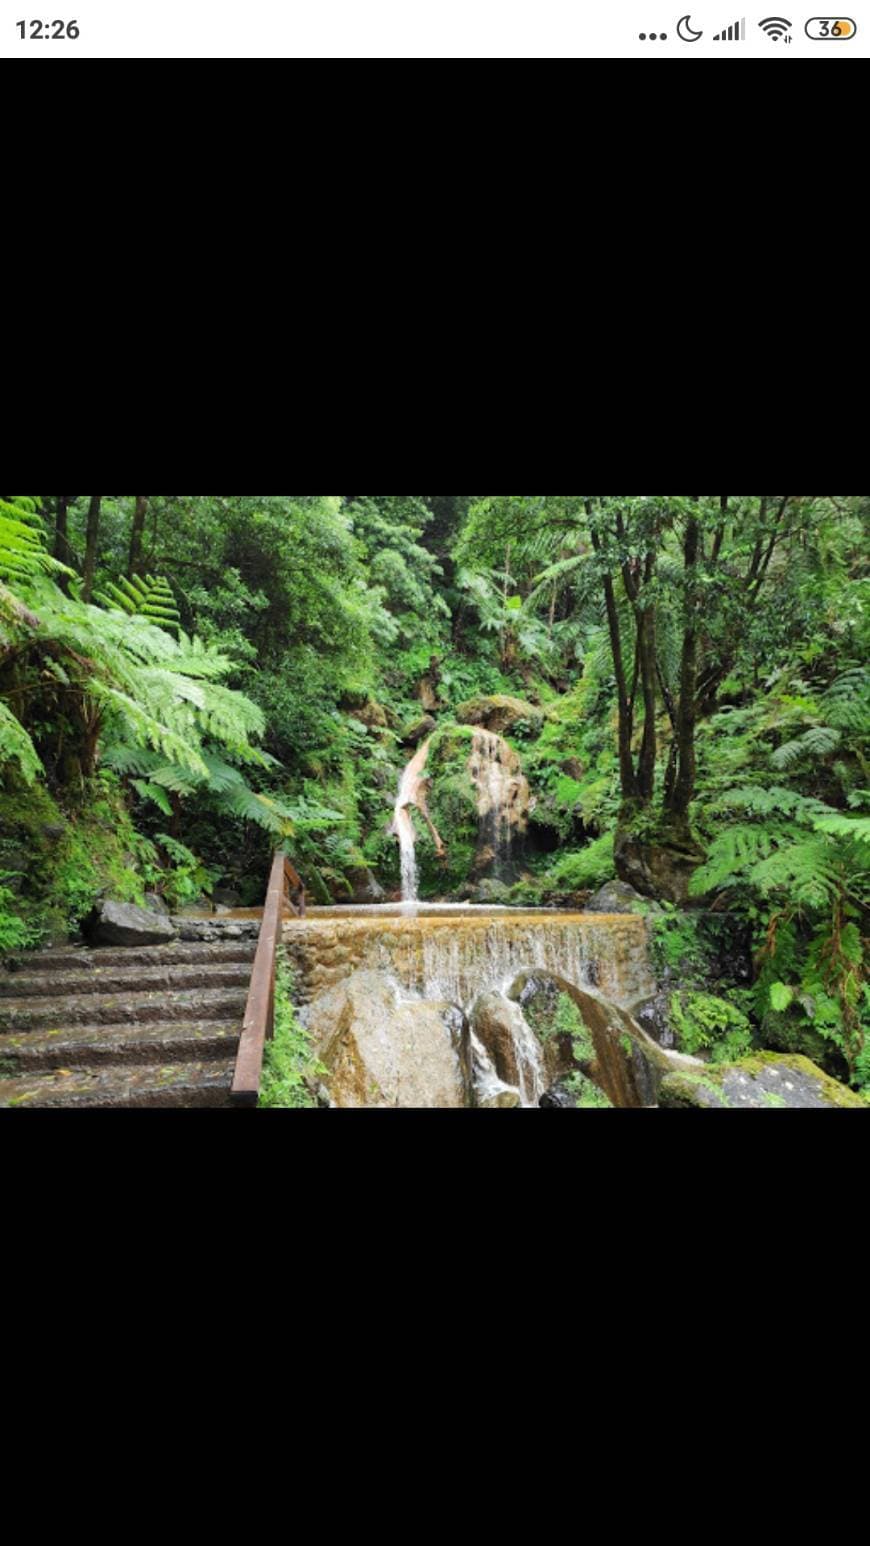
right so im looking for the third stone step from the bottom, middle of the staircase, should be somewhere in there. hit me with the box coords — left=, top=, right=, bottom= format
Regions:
left=0, top=982, right=247, bottom=1045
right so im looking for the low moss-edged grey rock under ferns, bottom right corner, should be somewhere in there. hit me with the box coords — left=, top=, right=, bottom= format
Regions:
left=658, top=1053, right=867, bottom=1112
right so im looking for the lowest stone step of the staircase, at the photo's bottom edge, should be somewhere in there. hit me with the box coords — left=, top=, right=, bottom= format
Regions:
left=0, top=1059, right=235, bottom=1108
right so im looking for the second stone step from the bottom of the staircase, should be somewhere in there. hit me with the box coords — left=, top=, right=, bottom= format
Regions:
left=0, top=1020, right=241, bottom=1078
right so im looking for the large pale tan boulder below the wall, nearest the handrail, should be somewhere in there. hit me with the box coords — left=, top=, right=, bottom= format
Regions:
left=304, top=971, right=471, bottom=1107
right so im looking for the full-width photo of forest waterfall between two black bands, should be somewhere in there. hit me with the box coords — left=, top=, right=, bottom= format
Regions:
left=0, top=495, right=870, bottom=1113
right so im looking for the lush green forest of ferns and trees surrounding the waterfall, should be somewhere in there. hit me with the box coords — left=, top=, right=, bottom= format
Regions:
left=0, top=495, right=870, bottom=1090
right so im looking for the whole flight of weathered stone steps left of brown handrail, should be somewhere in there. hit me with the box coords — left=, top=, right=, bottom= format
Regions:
left=0, top=934, right=257, bottom=1107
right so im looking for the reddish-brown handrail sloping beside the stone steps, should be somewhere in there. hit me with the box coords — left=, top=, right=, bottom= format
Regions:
left=230, top=853, right=304, bottom=1105
